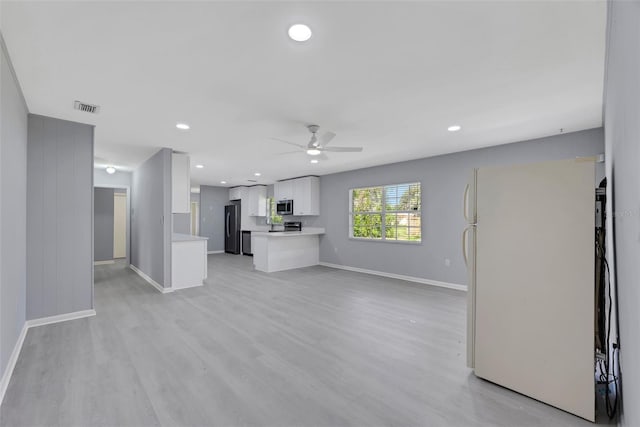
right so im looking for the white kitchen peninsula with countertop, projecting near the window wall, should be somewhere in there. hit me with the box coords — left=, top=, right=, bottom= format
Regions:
left=251, top=227, right=324, bottom=273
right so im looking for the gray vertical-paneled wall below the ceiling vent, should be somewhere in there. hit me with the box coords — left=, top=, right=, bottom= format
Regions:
left=27, top=115, right=93, bottom=319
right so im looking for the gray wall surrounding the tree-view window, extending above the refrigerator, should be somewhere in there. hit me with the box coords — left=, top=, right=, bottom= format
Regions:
left=315, top=128, right=604, bottom=285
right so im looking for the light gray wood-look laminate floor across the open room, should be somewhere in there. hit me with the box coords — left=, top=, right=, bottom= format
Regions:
left=0, top=254, right=590, bottom=426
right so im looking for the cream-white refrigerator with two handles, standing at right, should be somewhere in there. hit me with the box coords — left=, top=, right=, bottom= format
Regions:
left=462, top=159, right=595, bottom=421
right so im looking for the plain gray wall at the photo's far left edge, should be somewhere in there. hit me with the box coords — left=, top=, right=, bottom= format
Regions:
left=0, top=35, right=28, bottom=384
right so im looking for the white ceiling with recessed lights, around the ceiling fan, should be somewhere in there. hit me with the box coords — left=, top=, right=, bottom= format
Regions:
left=2, top=1, right=606, bottom=185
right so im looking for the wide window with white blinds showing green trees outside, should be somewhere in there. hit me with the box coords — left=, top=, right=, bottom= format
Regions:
left=349, top=182, right=422, bottom=243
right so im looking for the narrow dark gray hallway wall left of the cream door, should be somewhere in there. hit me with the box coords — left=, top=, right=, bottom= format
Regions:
left=93, top=187, right=114, bottom=261
